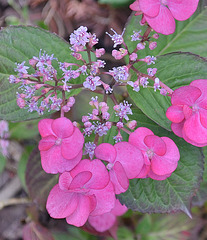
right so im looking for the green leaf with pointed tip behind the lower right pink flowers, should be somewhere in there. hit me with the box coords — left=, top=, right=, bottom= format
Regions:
left=118, top=110, right=204, bottom=216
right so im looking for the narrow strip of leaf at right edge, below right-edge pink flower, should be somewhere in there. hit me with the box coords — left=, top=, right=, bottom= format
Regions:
left=192, top=147, right=207, bottom=207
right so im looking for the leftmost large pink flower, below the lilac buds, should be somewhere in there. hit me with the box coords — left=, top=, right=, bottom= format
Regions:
left=38, top=117, right=84, bottom=173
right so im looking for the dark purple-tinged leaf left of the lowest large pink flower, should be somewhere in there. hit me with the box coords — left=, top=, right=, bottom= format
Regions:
left=26, top=148, right=58, bottom=208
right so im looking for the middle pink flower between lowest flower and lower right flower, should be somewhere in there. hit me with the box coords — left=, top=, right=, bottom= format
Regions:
left=95, top=142, right=144, bottom=194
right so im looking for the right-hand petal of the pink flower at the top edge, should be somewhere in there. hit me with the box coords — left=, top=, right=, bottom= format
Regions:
left=167, top=0, right=199, bottom=21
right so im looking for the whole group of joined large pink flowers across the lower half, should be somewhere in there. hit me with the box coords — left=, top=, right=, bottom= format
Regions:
left=39, top=117, right=180, bottom=232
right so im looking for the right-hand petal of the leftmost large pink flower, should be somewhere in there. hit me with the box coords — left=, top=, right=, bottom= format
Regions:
left=61, top=127, right=84, bottom=159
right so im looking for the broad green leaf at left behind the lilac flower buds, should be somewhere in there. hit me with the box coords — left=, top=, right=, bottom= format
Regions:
left=0, top=26, right=82, bottom=121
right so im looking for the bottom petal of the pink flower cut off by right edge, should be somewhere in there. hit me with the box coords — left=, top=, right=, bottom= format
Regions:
left=183, top=113, right=207, bottom=144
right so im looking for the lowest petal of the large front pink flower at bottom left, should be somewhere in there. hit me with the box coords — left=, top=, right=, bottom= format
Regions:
left=66, top=195, right=96, bottom=227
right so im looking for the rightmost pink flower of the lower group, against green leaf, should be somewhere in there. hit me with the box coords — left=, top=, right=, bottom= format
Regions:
left=129, top=127, right=180, bottom=180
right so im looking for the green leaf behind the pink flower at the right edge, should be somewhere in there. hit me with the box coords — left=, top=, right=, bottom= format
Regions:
left=128, top=53, right=207, bottom=130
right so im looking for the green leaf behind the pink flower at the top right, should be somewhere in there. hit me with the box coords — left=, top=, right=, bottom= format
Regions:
left=124, top=0, right=207, bottom=58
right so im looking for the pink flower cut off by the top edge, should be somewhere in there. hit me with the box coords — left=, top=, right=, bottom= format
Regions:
left=130, top=0, right=199, bottom=35
